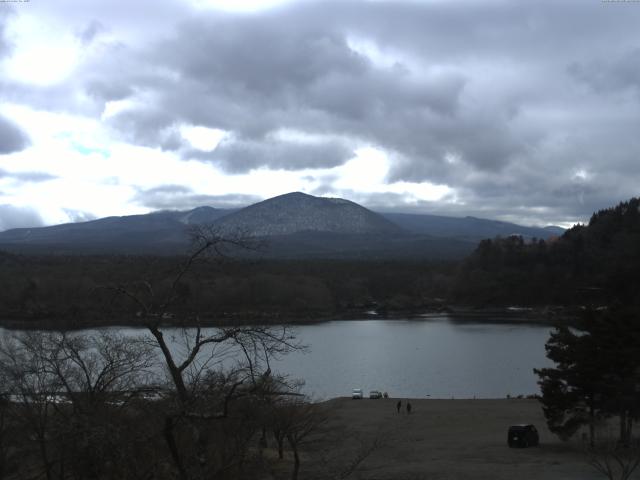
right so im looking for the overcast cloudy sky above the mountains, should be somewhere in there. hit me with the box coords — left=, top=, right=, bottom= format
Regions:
left=0, top=0, right=640, bottom=230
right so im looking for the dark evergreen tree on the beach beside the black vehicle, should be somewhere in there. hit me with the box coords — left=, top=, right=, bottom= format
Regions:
left=534, top=308, right=640, bottom=445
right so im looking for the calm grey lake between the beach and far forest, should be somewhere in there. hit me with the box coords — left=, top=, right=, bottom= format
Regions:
left=0, top=316, right=551, bottom=400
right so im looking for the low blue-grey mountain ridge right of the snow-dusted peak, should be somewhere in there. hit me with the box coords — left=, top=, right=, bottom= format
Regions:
left=381, top=213, right=564, bottom=242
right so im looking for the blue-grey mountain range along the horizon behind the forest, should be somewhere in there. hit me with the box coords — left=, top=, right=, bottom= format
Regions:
left=0, top=192, right=564, bottom=259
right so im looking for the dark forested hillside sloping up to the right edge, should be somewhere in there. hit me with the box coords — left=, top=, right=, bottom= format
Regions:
left=453, top=198, right=640, bottom=305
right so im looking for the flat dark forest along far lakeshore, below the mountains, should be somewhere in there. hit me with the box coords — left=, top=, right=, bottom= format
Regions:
left=0, top=254, right=457, bottom=327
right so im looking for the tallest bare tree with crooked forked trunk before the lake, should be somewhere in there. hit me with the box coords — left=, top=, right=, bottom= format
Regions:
left=109, top=226, right=300, bottom=480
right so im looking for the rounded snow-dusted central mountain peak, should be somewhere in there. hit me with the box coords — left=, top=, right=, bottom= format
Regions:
left=218, top=192, right=402, bottom=237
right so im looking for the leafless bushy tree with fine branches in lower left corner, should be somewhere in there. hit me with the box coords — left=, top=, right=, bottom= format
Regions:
left=0, top=332, right=159, bottom=479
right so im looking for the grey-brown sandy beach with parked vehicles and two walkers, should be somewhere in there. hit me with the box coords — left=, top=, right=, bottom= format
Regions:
left=276, top=398, right=602, bottom=480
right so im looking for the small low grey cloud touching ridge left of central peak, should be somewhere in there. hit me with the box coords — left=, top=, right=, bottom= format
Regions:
left=133, top=185, right=262, bottom=210
